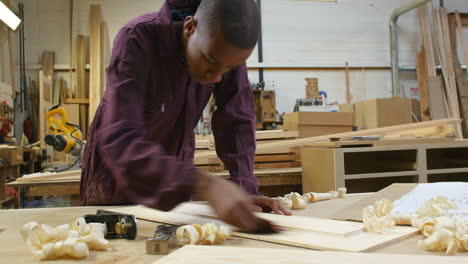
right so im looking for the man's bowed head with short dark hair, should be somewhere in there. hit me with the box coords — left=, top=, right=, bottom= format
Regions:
left=183, top=0, right=260, bottom=84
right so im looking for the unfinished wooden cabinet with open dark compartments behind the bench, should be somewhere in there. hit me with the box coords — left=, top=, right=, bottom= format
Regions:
left=301, top=140, right=468, bottom=192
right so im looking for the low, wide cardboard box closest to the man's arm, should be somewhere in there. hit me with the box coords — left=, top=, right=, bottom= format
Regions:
left=282, top=112, right=354, bottom=138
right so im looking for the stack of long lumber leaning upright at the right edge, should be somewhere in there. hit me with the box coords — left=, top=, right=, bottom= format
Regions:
left=416, top=4, right=468, bottom=138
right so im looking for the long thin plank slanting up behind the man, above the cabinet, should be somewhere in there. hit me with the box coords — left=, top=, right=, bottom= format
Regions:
left=195, top=118, right=461, bottom=158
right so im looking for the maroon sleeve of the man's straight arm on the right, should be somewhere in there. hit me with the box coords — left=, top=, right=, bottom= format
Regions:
left=212, top=64, right=258, bottom=194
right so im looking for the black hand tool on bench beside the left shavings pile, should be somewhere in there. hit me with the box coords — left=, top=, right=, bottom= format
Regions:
left=83, top=210, right=137, bottom=240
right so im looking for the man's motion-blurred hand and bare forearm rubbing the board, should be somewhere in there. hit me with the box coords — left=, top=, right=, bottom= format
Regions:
left=195, top=170, right=279, bottom=233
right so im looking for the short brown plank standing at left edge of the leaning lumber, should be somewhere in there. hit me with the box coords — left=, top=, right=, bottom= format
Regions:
left=416, top=46, right=431, bottom=121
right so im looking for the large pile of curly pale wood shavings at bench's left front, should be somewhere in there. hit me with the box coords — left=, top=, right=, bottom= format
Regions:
left=20, top=218, right=110, bottom=260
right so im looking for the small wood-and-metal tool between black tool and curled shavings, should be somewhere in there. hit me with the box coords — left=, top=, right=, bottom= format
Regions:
left=146, top=225, right=180, bottom=255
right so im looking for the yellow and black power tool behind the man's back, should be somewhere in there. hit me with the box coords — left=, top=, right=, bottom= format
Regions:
left=44, top=105, right=83, bottom=156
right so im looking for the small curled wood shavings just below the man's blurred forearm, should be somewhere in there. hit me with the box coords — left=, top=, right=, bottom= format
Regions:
left=176, top=223, right=231, bottom=245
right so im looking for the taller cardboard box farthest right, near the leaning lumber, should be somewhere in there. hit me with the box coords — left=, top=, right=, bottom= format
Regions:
left=354, top=97, right=413, bottom=130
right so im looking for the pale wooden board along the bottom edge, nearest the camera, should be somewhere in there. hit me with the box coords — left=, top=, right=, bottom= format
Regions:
left=154, top=245, right=466, bottom=264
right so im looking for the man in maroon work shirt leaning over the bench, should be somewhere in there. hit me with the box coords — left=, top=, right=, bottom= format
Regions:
left=81, top=0, right=289, bottom=232
